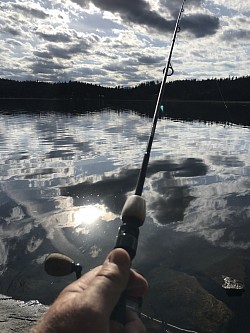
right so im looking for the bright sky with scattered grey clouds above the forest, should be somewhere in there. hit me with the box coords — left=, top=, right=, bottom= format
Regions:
left=0, top=0, right=250, bottom=87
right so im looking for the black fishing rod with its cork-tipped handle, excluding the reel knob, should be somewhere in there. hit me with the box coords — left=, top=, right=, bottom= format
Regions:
left=110, top=0, right=186, bottom=333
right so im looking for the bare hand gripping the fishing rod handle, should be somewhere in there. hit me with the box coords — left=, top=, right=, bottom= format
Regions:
left=32, top=249, right=148, bottom=333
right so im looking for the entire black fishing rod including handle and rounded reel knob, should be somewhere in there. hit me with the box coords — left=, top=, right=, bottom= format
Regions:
left=45, top=0, right=186, bottom=333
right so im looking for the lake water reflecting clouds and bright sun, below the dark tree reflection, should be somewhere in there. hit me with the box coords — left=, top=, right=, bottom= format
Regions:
left=0, top=102, right=250, bottom=333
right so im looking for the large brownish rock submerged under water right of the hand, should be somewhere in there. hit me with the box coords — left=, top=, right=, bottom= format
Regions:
left=144, top=267, right=233, bottom=333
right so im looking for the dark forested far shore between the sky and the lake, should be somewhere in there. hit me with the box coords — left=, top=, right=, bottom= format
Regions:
left=0, top=76, right=250, bottom=101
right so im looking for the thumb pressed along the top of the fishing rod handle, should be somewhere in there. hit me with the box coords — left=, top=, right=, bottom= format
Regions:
left=88, top=249, right=131, bottom=317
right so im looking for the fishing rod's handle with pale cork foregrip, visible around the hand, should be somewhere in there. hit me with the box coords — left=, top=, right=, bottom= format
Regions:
left=110, top=195, right=146, bottom=333
